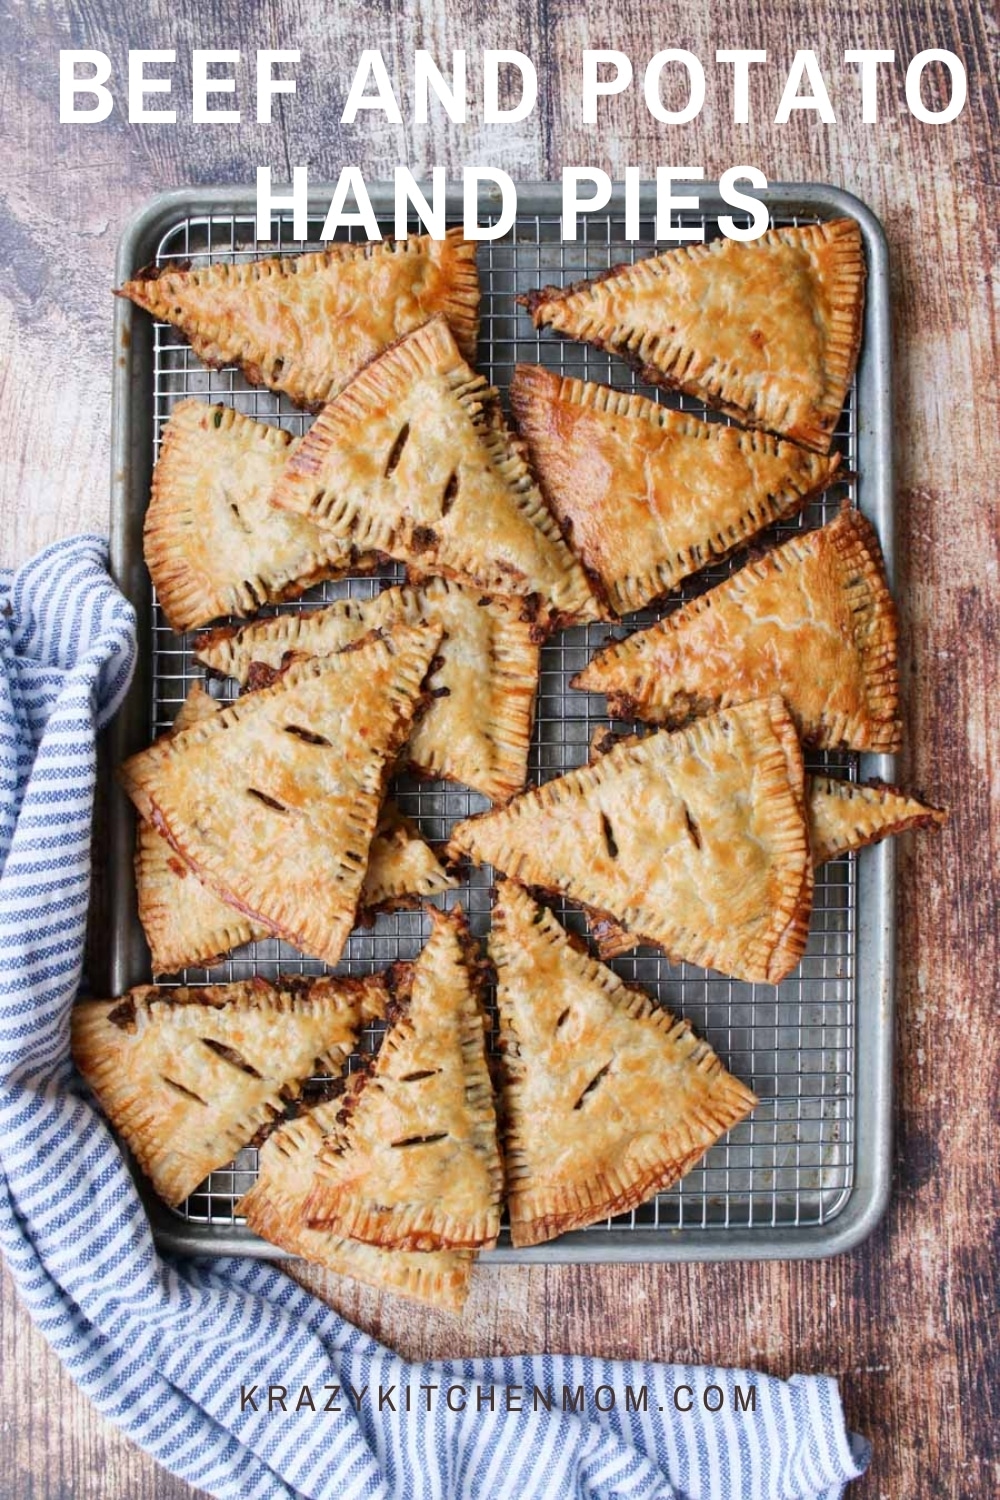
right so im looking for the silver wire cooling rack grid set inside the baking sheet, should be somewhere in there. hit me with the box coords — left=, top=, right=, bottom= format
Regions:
left=140, top=202, right=858, bottom=1260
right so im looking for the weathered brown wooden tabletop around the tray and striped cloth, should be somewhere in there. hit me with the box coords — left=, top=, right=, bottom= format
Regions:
left=0, top=0, right=1000, bottom=1500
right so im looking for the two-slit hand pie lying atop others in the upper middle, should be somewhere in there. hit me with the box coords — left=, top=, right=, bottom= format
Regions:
left=271, top=318, right=600, bottom=620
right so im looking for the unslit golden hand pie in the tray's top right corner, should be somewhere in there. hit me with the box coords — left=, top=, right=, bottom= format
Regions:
left=517, top=219, right=865, bottom=453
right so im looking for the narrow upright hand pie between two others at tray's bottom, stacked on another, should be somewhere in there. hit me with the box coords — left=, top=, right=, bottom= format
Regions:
left=303, top=911, right=502, bottom=1250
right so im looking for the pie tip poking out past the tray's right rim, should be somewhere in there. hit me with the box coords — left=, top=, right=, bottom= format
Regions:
left=805, top=776, right=948, bottom=866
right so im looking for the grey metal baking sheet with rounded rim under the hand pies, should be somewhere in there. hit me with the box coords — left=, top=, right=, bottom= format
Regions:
left=99, top=185, right=894, bottom=1263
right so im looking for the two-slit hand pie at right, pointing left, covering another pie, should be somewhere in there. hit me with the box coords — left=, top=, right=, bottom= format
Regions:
left=450, top=698, right=813, bottom=984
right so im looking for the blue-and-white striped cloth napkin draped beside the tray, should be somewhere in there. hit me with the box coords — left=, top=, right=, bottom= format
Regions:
left=0, top=537, right=868, bottom=1500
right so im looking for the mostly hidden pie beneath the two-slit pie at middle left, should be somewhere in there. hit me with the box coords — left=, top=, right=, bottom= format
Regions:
left=135, top=683, right=457, bottom=974
